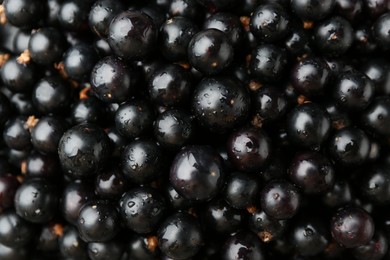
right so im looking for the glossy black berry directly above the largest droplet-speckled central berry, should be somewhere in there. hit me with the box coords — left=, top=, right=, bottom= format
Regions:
left=188, top=29, right=234, bottom=75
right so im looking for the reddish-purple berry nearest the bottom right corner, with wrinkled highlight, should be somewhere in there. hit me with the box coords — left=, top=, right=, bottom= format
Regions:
left=331, top=207, right=375, bottom=248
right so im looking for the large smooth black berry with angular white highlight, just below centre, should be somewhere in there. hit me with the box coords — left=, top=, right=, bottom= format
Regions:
left=169, top=145, right=225, bottom=201
